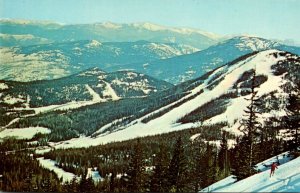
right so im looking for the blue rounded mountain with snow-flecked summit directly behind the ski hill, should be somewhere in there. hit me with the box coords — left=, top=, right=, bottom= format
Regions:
left=109, top=36, right=300, bottom=84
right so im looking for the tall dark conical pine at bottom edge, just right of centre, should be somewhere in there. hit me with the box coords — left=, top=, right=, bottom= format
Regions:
left=168, top=137, right=187, bottom=192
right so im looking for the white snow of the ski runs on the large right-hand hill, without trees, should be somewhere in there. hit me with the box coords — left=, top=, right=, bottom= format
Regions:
left=52, top=50, right=286, bottom=148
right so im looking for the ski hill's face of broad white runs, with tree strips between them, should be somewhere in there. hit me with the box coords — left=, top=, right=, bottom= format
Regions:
left=44, top=50, right=300, bottom=148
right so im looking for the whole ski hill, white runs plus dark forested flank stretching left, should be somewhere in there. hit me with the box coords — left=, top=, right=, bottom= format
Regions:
left=2, top=50, right=300, bottom=147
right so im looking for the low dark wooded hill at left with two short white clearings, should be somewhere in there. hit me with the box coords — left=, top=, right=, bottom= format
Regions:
left=0, top=68, right=172, bottom=109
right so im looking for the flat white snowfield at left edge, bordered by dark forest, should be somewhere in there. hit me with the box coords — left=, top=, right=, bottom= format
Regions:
left=0, top=127, right=51, bottom=139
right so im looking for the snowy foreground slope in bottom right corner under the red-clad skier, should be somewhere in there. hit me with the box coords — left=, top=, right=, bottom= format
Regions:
left=201, top=152, right=300, bottom=192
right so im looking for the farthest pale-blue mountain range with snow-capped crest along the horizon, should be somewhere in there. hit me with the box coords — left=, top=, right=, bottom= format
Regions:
left=0, top=19, right=221, bottom=49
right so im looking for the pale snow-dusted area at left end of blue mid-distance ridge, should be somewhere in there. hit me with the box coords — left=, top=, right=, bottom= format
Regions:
left=0, top=47, right=70, bottom=82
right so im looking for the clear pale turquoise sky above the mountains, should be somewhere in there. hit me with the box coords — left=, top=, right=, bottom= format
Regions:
left=0, top=0, right=300, bottom=42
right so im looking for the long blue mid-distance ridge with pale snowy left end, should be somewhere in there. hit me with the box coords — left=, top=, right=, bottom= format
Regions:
left=0, top=40, right=198, bottom=81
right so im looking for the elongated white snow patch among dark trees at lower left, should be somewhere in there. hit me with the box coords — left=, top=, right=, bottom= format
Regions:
left=37, top=157, right=76, bottom=182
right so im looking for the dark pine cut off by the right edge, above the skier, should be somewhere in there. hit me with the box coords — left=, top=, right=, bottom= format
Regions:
left=284, top=85, right=300, bottom=150
